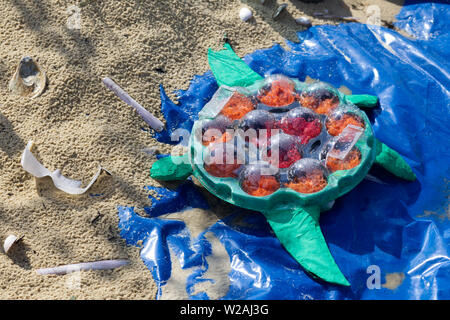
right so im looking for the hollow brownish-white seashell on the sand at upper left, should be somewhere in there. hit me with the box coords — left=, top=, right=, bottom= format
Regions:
left=9, top=57, right=47, bottom=99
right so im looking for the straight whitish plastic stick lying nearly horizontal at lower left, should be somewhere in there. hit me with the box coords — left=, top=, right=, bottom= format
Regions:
left=36, top=259, right=130, bottom=275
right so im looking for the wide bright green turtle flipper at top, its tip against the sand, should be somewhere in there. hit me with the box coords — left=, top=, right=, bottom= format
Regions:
left=208, top=43, right=263, bottom=87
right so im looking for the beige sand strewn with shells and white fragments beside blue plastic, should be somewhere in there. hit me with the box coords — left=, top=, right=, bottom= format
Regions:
left=0, top=0, right=401, bottom=299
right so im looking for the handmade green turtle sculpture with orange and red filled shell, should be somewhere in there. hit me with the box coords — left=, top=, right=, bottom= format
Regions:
left=150, top=44, right=416, bottom=286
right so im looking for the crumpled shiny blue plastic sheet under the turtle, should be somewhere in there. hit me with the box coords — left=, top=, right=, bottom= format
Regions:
left=119, top=3, right=450, bottom=299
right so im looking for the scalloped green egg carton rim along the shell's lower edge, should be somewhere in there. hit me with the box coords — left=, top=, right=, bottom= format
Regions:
left=189, top=101, right=376, bottom=212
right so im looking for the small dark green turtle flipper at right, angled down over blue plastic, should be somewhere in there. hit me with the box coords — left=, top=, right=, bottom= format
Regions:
left=375, top=140, right=416, bottom=181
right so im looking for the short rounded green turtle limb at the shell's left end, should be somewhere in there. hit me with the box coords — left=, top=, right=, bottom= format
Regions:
left=150, top=155, right=192, bottom=181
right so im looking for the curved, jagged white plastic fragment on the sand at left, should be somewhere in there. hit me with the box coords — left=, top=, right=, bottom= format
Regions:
left=20, top=141, right=110, bottom=194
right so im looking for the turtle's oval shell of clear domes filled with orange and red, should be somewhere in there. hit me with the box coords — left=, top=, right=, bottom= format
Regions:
left=189, top=75, right=376, bottom=212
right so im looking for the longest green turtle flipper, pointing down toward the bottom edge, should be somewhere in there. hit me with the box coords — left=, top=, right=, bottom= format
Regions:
left=264, top=206, right=350, bottom=286
